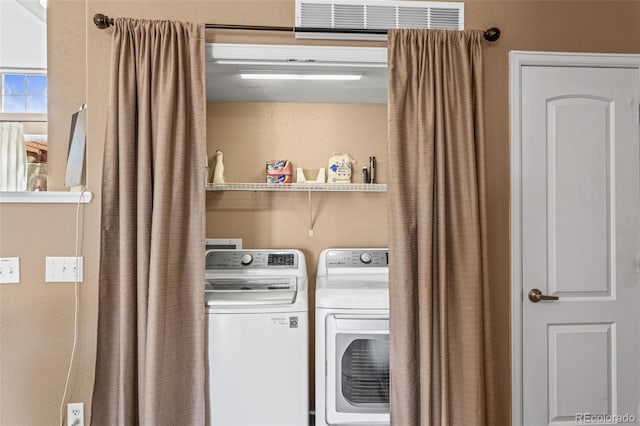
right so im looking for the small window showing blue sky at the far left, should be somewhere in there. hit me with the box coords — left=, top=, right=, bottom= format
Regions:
left=1, top=72, right=47, bottom=114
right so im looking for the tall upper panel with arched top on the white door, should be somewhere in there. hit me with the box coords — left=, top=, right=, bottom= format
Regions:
left=546, top=97, right=613, bottom=296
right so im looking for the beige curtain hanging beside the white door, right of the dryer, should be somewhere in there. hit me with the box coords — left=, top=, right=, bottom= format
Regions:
left=389, top=30, right=497, bottom=426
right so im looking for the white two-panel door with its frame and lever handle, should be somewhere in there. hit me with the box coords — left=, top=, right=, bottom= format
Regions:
left=512, top=53, right=640, bottom=426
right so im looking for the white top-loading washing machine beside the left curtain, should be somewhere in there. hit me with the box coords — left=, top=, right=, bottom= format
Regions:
left=205, top=250, right=309, bottom=426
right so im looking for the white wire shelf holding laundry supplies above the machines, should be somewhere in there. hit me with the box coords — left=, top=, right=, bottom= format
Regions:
left=207, top=183, right=387, bottom=192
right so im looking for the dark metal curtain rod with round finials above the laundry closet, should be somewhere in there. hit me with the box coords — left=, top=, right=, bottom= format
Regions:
left=93, top=13, right=500, bottom=42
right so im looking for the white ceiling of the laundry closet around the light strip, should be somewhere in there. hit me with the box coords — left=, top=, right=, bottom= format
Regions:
left=206, top=43, right=388, bottom=103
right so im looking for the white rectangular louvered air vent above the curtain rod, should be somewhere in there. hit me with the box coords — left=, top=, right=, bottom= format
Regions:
left=296, top=0, right=464, bottom=40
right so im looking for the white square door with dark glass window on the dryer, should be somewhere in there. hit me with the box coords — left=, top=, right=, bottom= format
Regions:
left=326, top=314, right=389, bottom=425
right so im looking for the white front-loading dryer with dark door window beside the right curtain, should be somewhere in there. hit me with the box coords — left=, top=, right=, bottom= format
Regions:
left=316, top=249, right=390, bottom=426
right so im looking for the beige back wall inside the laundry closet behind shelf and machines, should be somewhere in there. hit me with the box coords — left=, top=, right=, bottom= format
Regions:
left=207, top=103, right=387, bottom=404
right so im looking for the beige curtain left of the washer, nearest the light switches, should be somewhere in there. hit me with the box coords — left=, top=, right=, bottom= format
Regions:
left=91, top=19, right=206, bottom=426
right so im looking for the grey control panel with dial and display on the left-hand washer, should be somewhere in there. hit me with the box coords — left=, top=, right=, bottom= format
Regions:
left=205, top=250, right=298, bottom=269
